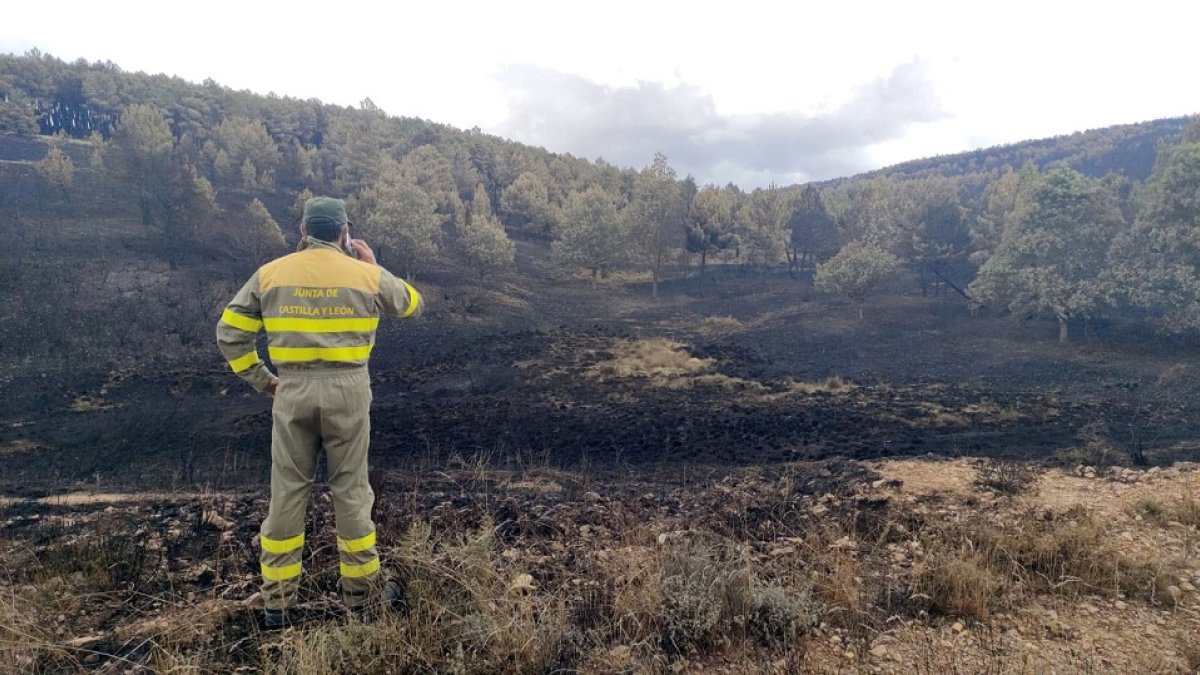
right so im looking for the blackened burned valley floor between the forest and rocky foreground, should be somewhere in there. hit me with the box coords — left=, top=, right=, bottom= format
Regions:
left=0, top=265, right=1196, bottom=492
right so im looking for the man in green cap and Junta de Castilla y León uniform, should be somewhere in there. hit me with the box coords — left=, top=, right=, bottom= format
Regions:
left=217, top=197, right=424, bottom=628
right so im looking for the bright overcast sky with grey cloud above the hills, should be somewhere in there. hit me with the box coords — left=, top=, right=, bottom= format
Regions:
left=0, top=0, right=1200, bottom=187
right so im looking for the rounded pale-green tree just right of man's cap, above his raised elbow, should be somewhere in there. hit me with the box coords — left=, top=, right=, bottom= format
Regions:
left=354, top=161, right=442, bottom=280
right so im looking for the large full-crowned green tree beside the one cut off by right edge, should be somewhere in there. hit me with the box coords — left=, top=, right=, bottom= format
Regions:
left=971, top=169, right=1123, bottom=342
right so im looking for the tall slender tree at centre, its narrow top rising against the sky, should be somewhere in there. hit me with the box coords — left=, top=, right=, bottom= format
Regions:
left=623, top=153, right=684, bottom=298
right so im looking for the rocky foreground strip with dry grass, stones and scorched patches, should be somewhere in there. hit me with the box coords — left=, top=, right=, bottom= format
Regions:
left=0, top=459, right=1200, bottom=673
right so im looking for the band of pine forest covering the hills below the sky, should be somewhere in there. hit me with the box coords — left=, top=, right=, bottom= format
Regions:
left=0, top=53, right=1200, bottom=340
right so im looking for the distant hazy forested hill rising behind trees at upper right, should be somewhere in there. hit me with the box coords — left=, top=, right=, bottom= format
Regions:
left=854, top=118, right=1189, bottom=180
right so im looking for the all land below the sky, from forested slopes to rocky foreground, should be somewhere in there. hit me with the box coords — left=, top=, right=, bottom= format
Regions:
left=0, top=49, right=1200, bottom=674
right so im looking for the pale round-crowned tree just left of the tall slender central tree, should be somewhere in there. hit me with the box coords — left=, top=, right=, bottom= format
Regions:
left=551, top=185, right=626, bottom=286
